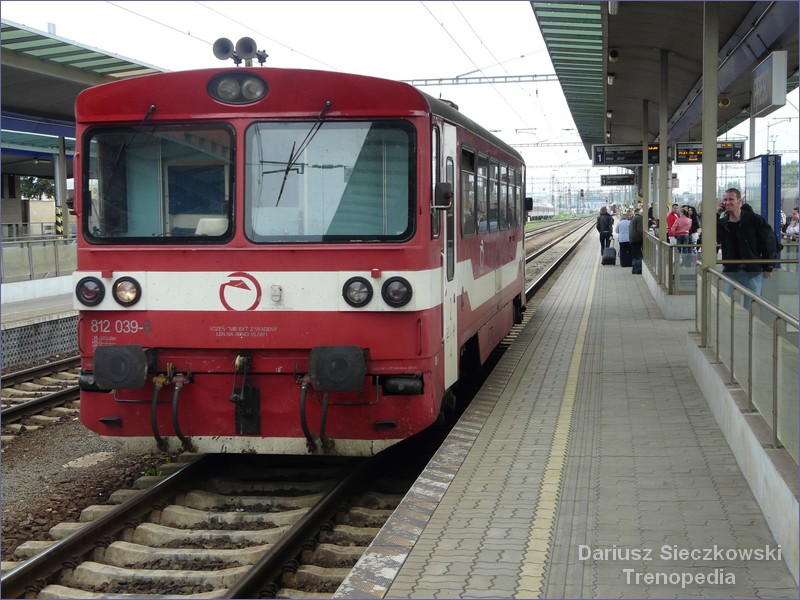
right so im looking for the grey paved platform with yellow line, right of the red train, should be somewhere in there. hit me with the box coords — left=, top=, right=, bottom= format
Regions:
left=335, top=235, right=798, bottom=598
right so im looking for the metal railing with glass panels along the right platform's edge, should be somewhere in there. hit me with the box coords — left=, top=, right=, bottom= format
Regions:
left=644, top=233, right=800, bottom=462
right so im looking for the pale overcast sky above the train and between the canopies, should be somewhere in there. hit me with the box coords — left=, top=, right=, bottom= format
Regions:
left=2, top=0, right=800, bottom=198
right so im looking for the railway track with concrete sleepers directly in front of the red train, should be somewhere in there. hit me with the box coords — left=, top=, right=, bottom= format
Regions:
left=0, top=445, right=432, bottom=598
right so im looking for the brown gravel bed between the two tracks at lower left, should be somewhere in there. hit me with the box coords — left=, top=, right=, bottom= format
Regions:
left=0, top=417, right=166, bottom=560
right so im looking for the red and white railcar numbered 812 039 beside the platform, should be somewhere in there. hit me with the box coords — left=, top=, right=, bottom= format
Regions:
left=74, top=59, right=525, bottom=456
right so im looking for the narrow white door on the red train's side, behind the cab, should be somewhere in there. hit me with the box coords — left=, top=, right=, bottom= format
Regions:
left=442, top=123, right=459, bottom=389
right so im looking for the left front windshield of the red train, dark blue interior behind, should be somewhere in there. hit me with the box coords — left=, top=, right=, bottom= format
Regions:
left=83, top=125, right=234, bottom=244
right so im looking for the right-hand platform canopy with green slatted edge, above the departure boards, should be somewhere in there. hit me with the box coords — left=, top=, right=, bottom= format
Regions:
left=531, top=0, right=800, bottom=156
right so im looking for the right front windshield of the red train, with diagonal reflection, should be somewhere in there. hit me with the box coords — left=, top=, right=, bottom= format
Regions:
left=245, top=121, right=416, bottom=243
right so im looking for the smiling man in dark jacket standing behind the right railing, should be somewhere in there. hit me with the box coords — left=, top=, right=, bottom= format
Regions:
left=717, top=188, right=777, bottom=306
